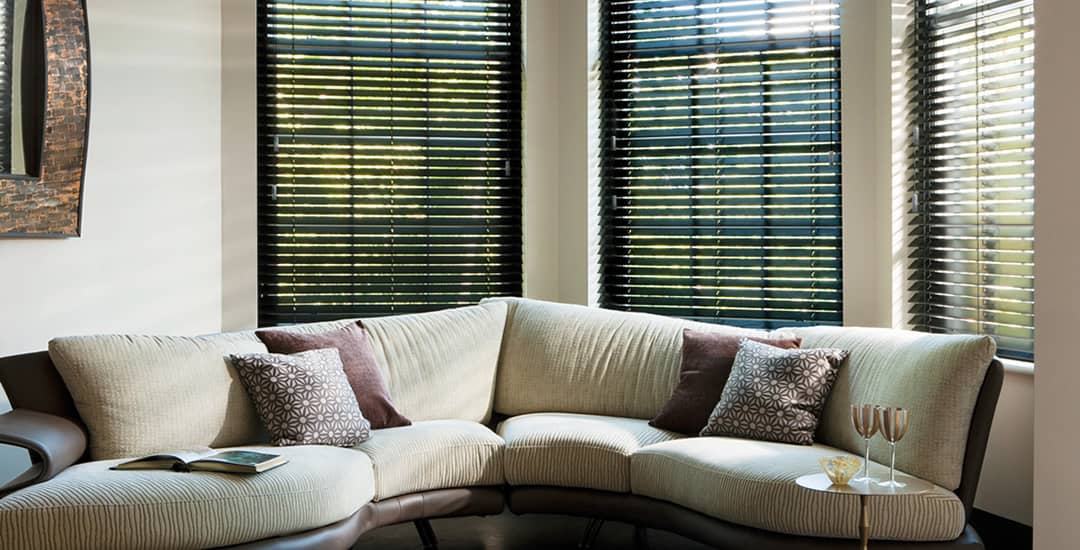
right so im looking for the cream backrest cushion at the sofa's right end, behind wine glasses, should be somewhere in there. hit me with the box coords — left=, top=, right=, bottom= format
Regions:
left=792, top=326, right=996, bottom=491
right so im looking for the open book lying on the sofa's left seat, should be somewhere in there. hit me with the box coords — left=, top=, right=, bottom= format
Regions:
left=111, top=448, right=288, bottom=473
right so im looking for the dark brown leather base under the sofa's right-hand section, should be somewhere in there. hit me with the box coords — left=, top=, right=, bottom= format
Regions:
left=508, top=487, right=985, bottom=550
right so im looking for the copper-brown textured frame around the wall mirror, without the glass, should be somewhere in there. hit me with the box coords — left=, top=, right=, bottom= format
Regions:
left=0, top=0, right=90, bottom=237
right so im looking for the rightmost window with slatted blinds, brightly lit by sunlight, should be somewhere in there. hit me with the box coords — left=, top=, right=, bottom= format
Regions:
left=907, top=0, right=1035, bottom=360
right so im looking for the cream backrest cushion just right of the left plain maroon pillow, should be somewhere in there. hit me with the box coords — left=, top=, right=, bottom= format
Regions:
left=250, top=301, right=507, bottom=422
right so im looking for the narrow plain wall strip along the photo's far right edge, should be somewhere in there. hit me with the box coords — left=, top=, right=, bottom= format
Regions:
left=1035, top=0, right=1080, bottom=550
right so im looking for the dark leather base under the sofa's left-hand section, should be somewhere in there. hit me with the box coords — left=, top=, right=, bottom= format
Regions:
left=222, top=487, right=505, bottom=550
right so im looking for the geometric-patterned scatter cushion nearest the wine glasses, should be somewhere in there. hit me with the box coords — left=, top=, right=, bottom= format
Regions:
left=701, top=338, right=848, bottom=445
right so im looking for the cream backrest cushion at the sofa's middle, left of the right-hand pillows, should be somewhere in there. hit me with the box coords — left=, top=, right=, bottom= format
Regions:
left=485, top=298, right=769, bottom=418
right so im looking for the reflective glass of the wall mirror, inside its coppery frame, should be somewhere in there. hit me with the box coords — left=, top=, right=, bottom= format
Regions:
left=0, top=0, right=44, bottom=176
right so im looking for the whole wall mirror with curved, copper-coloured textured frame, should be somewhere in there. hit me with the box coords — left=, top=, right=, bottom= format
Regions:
left=0, top=0, right=90, bottom=238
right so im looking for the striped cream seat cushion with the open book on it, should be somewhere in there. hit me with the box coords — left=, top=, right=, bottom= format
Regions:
left=0, top=446, right=375, bottom=550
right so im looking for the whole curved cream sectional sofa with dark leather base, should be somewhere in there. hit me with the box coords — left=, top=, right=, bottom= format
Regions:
left=0, top=298, right=1002, bottom=550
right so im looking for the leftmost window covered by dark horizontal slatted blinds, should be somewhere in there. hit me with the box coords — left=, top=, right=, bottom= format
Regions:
left=258, top=0, right=522, bottom=325
